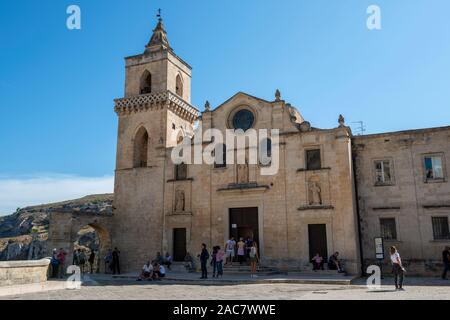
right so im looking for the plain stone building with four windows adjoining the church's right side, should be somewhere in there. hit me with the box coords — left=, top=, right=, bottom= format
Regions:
left=353, top=127, right=450, bottom=274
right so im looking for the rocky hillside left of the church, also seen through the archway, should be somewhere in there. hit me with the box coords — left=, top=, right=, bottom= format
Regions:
left=0, top=194, right=113, bottom=261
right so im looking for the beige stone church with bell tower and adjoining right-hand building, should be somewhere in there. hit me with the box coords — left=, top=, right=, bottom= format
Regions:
left=111, top=19, right=450, bottom=274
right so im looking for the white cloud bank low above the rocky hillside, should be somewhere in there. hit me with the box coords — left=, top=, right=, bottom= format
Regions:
left=0, top=174, right=114, bottom=215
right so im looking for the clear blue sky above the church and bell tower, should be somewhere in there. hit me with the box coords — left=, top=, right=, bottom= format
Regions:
left=0, top=0, right=450, bottom=212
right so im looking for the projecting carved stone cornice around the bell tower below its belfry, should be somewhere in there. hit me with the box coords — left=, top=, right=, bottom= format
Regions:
left=114, top=90, right=200, bottom=122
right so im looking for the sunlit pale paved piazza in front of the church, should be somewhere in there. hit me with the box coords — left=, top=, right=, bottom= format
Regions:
left=0, top=278, right=450, bottom=300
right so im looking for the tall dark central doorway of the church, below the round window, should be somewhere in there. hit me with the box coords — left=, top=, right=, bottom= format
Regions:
left=229, top=208, right=260, bottom=246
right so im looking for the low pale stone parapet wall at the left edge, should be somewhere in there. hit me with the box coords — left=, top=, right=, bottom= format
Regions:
left=0, top=259, right=50, bottom=287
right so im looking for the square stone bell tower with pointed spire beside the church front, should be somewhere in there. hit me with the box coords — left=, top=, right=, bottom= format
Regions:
left=112, top=15, right=199, bottom=271
